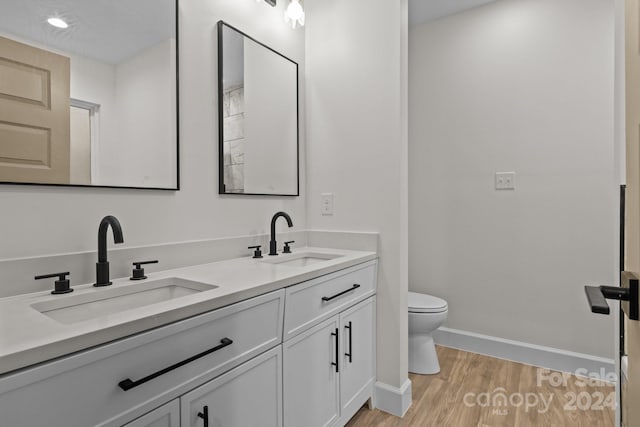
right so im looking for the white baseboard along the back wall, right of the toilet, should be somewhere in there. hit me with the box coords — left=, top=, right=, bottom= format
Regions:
left=433, top=327, right=615, bottom=376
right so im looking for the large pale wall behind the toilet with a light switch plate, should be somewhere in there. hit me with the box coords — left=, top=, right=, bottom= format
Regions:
left=409, top=0, right=618, bottom=358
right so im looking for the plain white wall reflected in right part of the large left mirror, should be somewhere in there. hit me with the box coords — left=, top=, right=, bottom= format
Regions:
left=112, top=39, right=177, bottom=188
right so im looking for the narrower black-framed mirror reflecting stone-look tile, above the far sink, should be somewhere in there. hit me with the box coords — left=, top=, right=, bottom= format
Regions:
left=218, top=21, right=300, bottom=196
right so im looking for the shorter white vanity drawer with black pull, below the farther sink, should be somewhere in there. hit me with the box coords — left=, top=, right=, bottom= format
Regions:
left=284, top=261, right=378, bottom=341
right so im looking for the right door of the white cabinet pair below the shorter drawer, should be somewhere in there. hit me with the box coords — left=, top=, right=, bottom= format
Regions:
left=340, top=297, right=376, bottom=422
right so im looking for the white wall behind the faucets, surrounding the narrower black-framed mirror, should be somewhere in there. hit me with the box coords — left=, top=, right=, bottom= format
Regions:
left=0, top=0, right=306, bottom=259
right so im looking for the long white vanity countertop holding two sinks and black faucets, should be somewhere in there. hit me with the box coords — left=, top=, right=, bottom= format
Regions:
left=0, top=248, right=377, bottom=374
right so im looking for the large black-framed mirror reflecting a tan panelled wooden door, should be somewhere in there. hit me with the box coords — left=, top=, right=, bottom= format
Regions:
left=0, top=0, right=180, bottom=190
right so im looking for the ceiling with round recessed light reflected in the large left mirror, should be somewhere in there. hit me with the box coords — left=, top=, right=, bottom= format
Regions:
left=0, top=0, right=176, bottom=64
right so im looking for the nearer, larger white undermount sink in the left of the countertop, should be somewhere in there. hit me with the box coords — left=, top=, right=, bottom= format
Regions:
left=31, top=277, right=218, bottom=323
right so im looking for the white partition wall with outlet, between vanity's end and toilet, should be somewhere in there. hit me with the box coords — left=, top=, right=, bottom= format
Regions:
left=305, top=0, right=407, bottom=387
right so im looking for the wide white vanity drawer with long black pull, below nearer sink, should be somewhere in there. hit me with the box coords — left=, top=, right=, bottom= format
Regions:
left=0, top=290, right=284, bottom=427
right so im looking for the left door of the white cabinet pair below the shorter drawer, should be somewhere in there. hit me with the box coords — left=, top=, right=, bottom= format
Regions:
left=283, top=316, right=341, bottom=427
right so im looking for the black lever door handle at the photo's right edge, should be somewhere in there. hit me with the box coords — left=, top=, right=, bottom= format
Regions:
left=584, top=271, right=640, bottom=320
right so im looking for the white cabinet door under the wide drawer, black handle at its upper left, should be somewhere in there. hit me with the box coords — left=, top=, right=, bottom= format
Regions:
left=180, top=346, right=282, bottom=427
